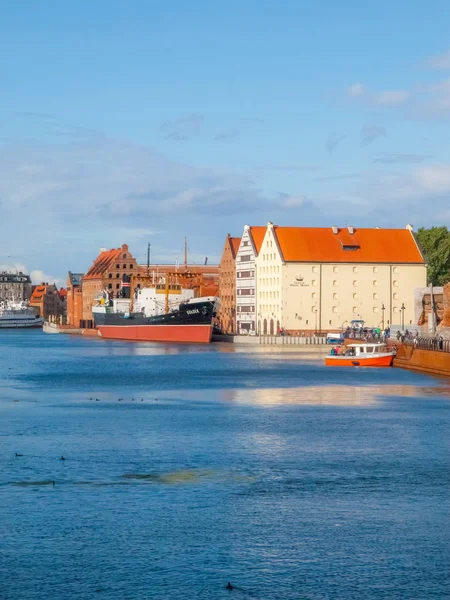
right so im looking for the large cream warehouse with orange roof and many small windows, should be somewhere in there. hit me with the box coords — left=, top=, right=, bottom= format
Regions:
left=255, top=223, right=427, bottom=334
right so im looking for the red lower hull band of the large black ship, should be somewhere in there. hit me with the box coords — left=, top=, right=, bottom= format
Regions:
left=98, top=325, right=212, bottom=344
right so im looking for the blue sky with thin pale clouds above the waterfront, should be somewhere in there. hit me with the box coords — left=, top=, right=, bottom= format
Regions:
left=0, top=0, right=450, bottom=280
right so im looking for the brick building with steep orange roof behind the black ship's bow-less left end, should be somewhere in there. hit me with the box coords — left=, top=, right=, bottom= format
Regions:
left=81, top=244, right=139, bottom=329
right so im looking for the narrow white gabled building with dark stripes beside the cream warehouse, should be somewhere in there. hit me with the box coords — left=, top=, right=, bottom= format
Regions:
left=236, top=225, right=266, bottom=333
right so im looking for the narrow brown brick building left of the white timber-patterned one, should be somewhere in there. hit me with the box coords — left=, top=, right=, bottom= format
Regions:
left=218, top=234, right=241, bottom=333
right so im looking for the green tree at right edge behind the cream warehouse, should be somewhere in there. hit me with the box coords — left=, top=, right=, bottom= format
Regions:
left=417, top=226, right=450, bottom=285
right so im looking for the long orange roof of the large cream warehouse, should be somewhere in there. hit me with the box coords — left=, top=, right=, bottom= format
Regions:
left=274, top=226, right=425, bottom=264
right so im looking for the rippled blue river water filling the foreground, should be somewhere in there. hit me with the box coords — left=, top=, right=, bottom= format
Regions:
left=0, top=331, right=450, bottom=600
